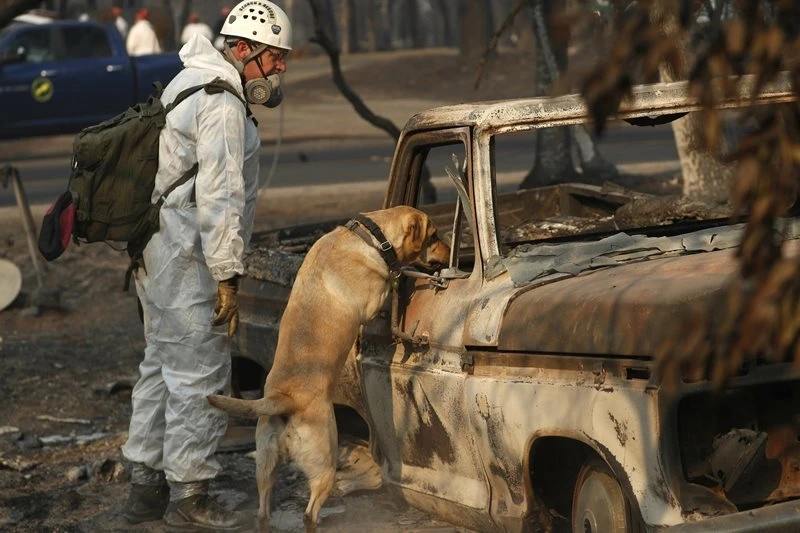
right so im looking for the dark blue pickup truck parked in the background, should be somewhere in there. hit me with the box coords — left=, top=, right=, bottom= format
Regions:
left=0, top=20, right=182, bottom=138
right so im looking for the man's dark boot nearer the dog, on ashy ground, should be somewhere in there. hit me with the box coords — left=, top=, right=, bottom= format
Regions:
left=164, top=482, right=248, bottom=531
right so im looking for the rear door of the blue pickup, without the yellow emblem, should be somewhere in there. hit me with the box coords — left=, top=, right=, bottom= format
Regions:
left=53, top=25, right=134, bottom=128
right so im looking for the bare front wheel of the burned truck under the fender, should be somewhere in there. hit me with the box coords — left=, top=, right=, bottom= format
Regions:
left=572, top=458, right=634, bottom=533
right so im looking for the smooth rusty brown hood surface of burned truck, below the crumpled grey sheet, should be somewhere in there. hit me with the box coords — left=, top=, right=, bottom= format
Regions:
left=498, top=241, right=800, bottom=356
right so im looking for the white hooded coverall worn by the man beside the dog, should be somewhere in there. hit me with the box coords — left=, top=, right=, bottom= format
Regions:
left=122, top=35, right=260, bottom=483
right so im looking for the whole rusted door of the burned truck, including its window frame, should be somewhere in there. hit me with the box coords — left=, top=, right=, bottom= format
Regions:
left=362, top=128, right=490, bottom=520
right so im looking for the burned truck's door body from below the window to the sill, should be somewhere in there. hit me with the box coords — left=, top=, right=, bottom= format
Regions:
left=361, top=271, right=490, bottom=510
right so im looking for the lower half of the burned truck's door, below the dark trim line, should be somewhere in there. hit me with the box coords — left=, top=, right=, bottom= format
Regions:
left=362, top=347, right=490, bottom=510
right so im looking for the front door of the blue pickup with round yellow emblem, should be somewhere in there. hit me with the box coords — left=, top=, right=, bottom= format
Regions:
left=0, top=26, right=65, bottom=132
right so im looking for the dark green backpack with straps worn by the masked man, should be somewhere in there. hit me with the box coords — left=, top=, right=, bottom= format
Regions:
left=68, top=78, right=246, bottom=284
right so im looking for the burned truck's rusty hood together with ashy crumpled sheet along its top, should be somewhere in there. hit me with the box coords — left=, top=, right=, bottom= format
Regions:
left=497, top=223, right=800, bottom=357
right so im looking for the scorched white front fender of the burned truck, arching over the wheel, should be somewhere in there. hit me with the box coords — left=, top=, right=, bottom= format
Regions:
left=464, top=364, right=682, bottom=526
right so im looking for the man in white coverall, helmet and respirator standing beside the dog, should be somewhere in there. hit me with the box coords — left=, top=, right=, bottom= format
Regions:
left=122, top=0, right=292, bottom=531
